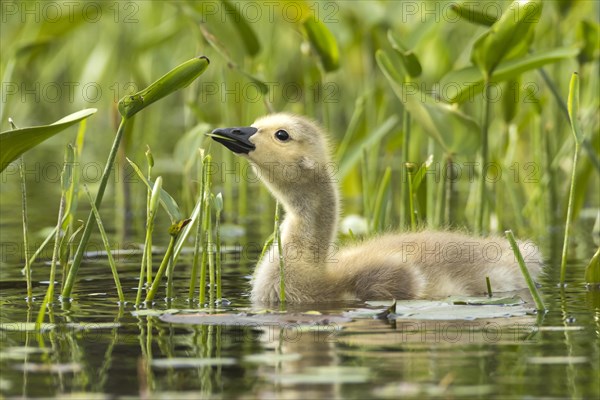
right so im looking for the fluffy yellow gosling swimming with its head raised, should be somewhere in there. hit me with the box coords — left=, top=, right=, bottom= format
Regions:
left=209, top=113, right=541, bottom=303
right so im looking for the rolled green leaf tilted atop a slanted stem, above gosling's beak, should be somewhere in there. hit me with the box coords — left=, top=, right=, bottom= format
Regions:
left=118, top=56, right=210, bottom=118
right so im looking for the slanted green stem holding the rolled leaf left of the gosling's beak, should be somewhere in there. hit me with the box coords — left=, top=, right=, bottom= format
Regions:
left=61, top=117, right=128, bottom=299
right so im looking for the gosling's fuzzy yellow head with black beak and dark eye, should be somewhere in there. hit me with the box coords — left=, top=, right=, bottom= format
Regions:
left=209, top=113, right=333, bottom=190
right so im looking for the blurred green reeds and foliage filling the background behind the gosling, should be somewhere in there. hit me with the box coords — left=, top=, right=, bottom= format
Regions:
left=0, top=1, right=600, bottom=264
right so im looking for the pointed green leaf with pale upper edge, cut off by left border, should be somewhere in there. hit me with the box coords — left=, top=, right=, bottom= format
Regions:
left=0, top=108, right=97, bottom=172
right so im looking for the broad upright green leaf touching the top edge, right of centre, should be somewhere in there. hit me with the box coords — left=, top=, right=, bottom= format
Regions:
left=471, top=0, right=542, bottom=78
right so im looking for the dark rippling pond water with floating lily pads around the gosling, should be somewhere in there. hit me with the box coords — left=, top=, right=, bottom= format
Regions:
left=0, top=191, right=600, bottom=399
